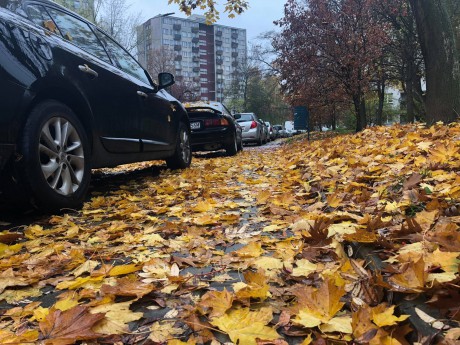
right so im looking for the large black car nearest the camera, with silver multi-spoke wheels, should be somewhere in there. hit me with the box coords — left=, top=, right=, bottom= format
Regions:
left=0, top=0, right=191, bottom=210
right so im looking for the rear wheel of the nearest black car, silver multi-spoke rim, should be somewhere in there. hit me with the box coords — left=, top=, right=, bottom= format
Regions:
left=18, top=100, right=91, bottom=211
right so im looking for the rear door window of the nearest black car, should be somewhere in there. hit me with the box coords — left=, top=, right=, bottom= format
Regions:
left=45, top=8, right=111, bottom=63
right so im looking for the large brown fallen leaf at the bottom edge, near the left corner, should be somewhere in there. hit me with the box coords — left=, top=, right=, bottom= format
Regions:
left=39, top=305, right=104, bottom=345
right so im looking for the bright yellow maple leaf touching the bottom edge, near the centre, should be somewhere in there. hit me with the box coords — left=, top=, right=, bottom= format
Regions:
left=211, top=308, right=280, bottom=345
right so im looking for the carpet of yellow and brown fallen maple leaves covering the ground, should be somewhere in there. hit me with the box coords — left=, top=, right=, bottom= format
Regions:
left=0, top=124, right=460, bottom=345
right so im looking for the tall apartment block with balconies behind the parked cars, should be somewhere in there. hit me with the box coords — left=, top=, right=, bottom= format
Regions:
left=137, top=14, right=247, bottom=101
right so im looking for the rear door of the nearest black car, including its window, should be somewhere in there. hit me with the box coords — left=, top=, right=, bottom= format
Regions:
left=28, top=5, right=141, bottom=153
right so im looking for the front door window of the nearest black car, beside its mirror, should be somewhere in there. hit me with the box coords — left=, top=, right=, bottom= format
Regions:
left=97, top=31, right=150, bottom=84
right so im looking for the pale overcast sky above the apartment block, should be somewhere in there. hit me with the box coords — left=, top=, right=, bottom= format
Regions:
left=131, top=0, right=285, bottom=43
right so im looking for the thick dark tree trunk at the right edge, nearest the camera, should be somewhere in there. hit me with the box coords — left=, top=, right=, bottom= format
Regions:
left=410, top=0, right=460, bottom=124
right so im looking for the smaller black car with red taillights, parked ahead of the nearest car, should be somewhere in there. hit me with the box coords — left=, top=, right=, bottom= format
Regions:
left=185, top=101, right=243, bottom=156
